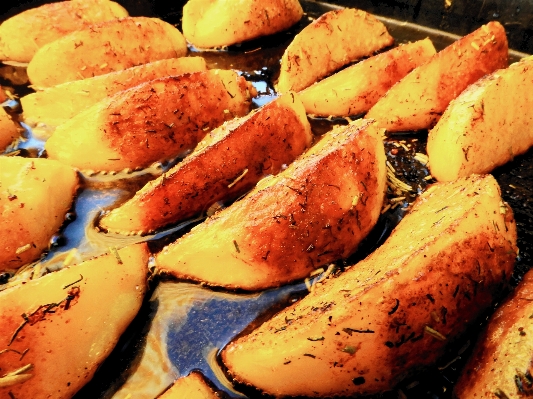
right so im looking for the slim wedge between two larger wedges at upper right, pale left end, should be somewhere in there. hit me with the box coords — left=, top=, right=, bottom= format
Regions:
left=298, top=39, right=435, bottom=116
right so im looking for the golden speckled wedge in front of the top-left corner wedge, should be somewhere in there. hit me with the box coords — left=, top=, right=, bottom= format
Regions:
left=28, top=17, right=187, bottom=88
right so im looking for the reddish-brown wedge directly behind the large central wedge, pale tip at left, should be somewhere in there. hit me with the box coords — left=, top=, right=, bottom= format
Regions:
left=100, top=93, right=312, bottom=234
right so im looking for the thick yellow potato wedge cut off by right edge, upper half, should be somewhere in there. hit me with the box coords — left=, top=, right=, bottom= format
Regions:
left=427, top=57, right=533, bottom=180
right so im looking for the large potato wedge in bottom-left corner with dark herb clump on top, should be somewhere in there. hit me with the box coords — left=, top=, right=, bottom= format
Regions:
left=0, top=244, right=149, bottom=399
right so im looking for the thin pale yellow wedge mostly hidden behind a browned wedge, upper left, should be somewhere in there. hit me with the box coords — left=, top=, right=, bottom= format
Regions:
left=20, top=57, right=207, bottom=127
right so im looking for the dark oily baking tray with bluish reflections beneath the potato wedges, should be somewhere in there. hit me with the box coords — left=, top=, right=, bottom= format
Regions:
left=0, top=0, right=533, bottom=399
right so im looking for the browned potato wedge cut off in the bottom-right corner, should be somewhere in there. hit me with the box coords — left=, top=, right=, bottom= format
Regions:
left=454, top=271, right=533, bottom=399
